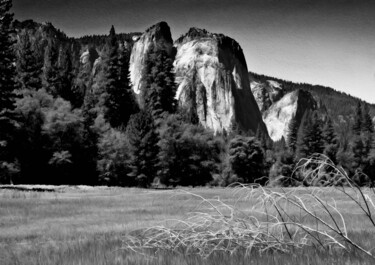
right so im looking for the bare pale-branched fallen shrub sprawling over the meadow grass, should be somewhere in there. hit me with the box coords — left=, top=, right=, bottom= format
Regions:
left=123, top=155, right=375, bottom=257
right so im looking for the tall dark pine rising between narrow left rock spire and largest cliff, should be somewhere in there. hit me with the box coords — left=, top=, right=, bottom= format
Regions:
left=144, top=43, right=177, bottom=118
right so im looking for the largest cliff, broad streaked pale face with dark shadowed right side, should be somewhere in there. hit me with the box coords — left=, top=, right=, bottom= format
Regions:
left=174, top=28, right=267, bottom=135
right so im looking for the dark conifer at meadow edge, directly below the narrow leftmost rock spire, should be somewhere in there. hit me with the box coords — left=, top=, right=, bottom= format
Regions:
left=126, top=110, right=159, bottom=187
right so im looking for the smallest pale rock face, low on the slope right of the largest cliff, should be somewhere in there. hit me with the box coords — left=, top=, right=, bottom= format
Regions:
left=263, top=90, right=317, bottom=141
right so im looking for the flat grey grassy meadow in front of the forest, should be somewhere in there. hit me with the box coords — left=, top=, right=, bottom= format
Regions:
left=0, top=187, right=375, bottom=265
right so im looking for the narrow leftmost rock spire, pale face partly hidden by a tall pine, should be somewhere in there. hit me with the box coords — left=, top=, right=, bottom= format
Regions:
left=129, top=22, right=174, bottom=104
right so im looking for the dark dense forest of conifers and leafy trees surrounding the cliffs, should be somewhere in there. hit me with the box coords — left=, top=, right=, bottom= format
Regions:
left=0, top=0, right=375, bottom=187
